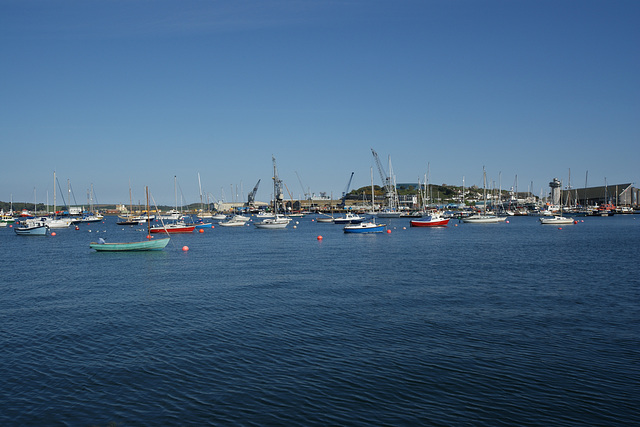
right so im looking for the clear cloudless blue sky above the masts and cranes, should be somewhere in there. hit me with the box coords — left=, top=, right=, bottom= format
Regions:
left=0, top=0, right=640, bottom=205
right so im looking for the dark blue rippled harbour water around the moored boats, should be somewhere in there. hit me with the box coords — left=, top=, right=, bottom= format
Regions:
left=0, top=215, right=640, bottom=426
